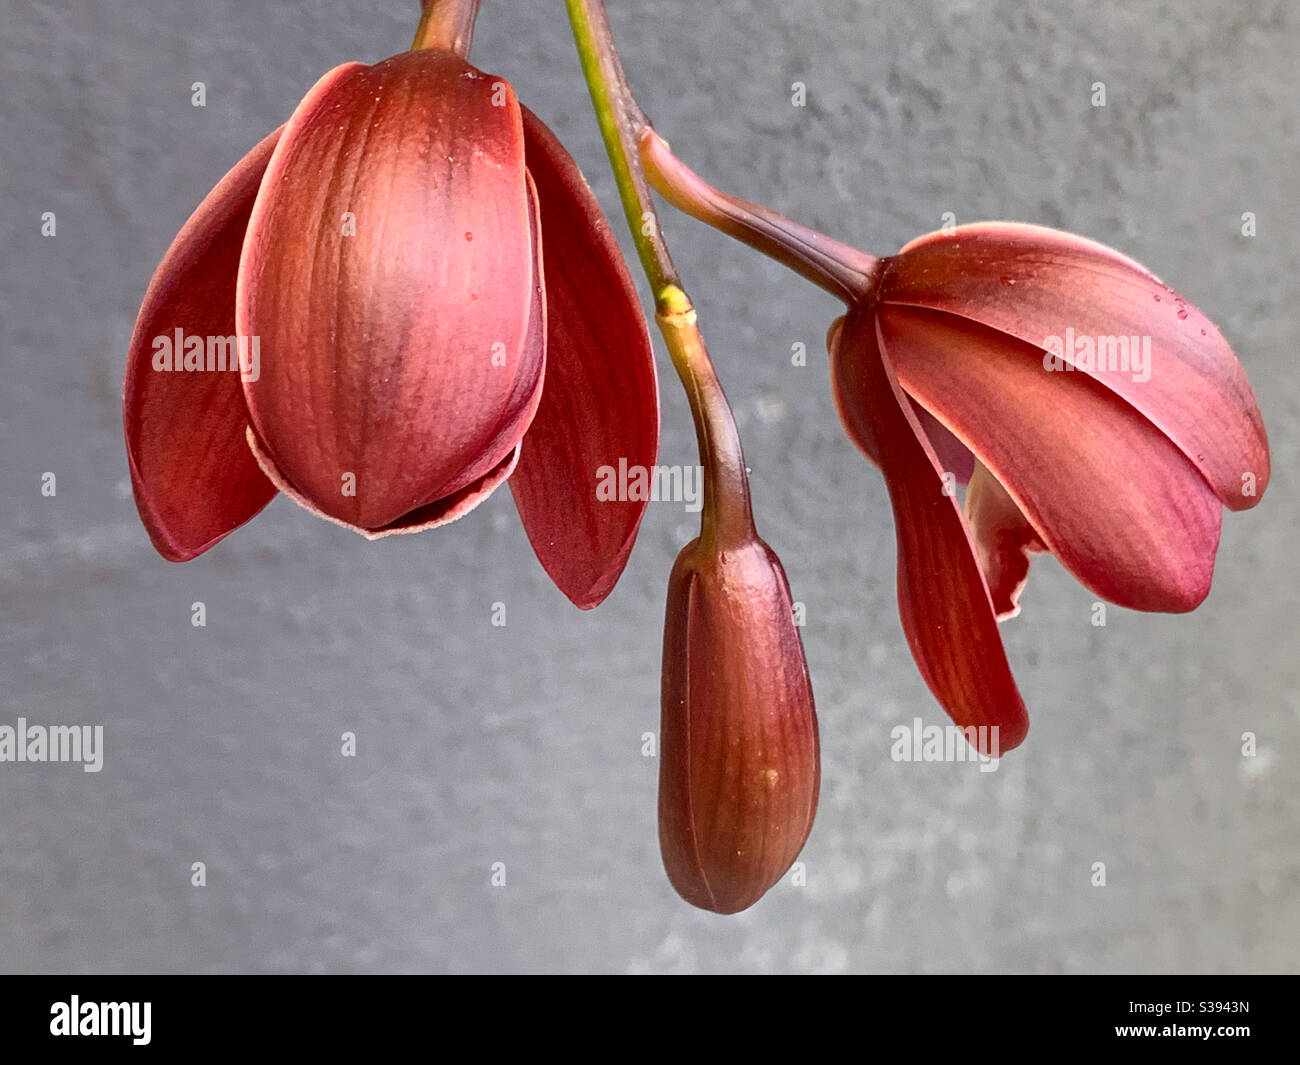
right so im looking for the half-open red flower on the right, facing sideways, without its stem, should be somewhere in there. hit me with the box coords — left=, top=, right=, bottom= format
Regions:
left=828, top=222, right=1269, bottom=750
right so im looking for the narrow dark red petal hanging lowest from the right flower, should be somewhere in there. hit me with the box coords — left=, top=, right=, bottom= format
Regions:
left=831, top=306, right=1028, bottom=754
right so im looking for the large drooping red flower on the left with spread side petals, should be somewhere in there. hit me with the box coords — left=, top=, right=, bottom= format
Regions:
left=124, top=48, right=659, bottom=607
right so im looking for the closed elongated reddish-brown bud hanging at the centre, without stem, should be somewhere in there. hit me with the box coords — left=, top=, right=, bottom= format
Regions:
left=659, top=529, right=820, bottom=913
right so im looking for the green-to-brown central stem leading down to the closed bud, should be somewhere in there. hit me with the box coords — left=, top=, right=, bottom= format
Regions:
left=564, top=0, right=754, bottom=549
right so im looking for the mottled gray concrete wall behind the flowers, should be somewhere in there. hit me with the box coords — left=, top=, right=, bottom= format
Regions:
left=0, top=0, right=1300, bottom=973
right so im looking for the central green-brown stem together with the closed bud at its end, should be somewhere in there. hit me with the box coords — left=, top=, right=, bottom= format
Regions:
left=567, top=0, right=820, bottom=913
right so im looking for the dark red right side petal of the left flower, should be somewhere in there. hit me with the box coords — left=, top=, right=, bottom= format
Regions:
left=510, top=108, right=659, bottom=609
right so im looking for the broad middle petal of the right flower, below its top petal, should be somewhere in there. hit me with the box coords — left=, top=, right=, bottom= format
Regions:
left=879, top=306, right=1222, bottom=611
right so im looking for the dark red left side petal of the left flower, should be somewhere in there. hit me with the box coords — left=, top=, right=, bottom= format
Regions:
left=122, top=130, right=281, bottom=562
